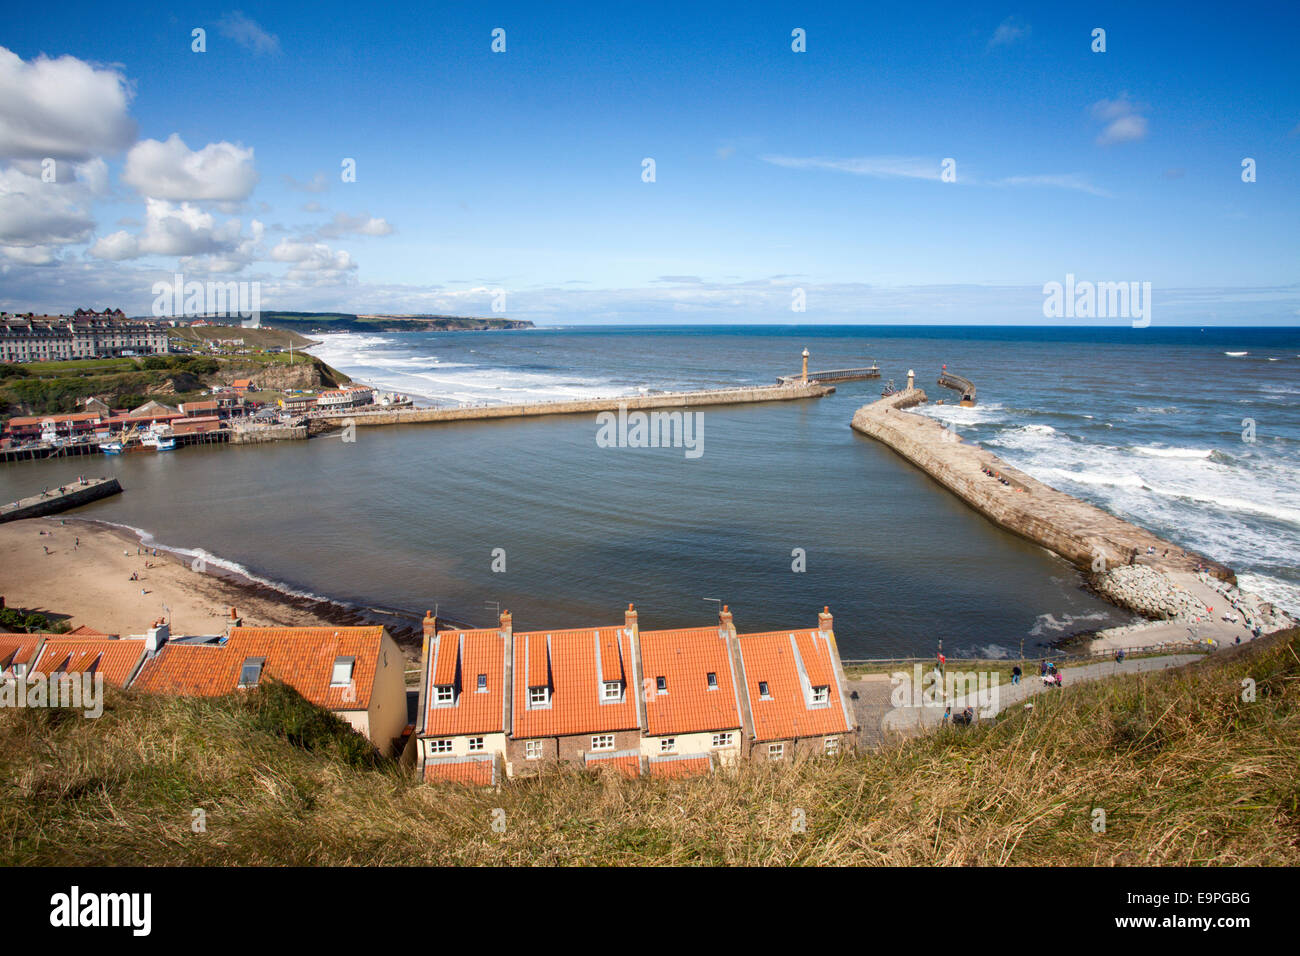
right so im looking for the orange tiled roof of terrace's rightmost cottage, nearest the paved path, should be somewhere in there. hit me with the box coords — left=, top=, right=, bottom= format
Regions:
left=738, top=630, right=849, bottom=741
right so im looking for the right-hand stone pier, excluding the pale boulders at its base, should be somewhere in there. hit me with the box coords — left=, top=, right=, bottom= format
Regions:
left=853, top=389, right=1235, bottom=583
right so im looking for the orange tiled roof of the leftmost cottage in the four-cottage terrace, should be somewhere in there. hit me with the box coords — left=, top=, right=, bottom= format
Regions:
left=423, top=630, right=506, bottom=737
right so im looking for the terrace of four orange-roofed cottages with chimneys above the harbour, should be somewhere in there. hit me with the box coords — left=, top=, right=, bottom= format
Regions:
left=416, top=605, right=855, bottom=784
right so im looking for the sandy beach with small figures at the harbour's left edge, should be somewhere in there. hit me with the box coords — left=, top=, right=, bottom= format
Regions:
left=0, top=518, right=392, bottom=647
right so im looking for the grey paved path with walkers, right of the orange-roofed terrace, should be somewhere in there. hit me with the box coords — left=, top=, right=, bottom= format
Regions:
left=848, top=654, right=1201, bottom=748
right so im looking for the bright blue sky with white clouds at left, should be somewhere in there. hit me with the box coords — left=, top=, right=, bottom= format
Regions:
left=0, top=3, right=1300, bottom=325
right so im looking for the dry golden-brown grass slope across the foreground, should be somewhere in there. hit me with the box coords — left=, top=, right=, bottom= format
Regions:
left=0, top=631, right=1300, bottom=865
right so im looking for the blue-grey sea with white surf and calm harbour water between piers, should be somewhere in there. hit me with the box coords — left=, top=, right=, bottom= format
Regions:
left=0, top=325, right=1300, bottom=659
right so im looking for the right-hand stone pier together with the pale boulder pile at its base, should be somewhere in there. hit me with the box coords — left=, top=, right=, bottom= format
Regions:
left=852, top=388, right=1291, bottom=649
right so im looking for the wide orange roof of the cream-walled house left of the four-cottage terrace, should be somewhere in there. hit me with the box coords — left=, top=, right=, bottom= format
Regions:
left=133, top=627, right=386, bottom=710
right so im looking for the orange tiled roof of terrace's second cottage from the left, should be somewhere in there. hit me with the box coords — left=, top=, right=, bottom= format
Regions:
left=512, top=627, right=637, bottom=739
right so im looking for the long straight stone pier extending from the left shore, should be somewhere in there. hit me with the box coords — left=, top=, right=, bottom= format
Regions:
left=312, top=381, right=835, bottom=425
